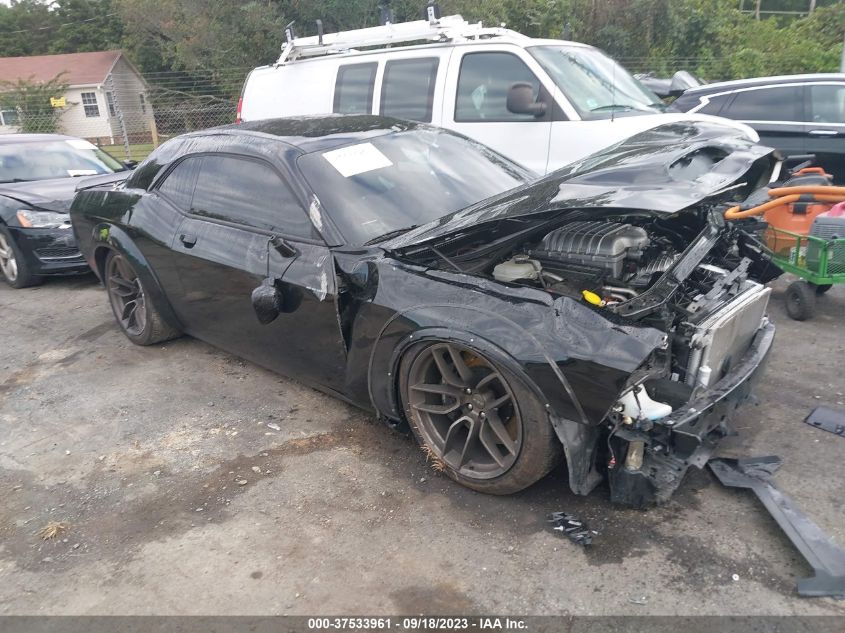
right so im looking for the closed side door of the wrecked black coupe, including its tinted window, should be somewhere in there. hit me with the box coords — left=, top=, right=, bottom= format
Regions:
left=168, top=154, right=346, bottom=392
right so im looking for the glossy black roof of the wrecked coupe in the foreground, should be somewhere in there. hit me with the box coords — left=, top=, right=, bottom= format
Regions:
left=186, top=114, right=426, bottom=153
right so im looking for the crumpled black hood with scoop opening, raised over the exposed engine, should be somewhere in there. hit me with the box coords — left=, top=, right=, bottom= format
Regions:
left=379, top=120, right=775, bottom=251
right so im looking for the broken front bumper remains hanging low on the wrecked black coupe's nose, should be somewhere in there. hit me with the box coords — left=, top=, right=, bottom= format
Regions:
left=608, top=323, right=775, bottom=508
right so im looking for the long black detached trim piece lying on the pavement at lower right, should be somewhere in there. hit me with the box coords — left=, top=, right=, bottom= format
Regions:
left=709, top=457, right=845, bottom=599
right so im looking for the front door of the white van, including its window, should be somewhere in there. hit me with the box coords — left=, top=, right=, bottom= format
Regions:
left=441, top=47, right=556, bottom=174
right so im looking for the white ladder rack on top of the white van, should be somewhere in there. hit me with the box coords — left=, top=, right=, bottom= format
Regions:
left=276, top=15, right=525, bottom=66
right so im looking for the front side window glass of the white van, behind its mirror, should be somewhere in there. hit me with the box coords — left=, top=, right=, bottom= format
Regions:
left=455, top=52, right=540, bottom=122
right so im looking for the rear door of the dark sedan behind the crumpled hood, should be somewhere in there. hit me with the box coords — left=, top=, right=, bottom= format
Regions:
left=719, top=84, right=807, bottom=155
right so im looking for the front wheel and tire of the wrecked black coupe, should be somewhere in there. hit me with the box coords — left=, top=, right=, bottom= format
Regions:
left=399, top=342, right=562, bottom=495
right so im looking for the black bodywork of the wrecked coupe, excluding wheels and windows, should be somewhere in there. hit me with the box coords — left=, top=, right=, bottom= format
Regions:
left=71, top=116, right=775, bottom=505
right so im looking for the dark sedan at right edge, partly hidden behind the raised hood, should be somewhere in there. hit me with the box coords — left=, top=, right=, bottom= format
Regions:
left=670, top=73, right=845, bottom=183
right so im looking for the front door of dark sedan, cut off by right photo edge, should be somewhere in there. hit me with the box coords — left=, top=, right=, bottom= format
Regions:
left=806, top=83, right=845, bottom=183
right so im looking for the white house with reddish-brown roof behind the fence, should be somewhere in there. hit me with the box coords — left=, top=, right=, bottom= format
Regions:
left=0, top=51, right=155, bottom=144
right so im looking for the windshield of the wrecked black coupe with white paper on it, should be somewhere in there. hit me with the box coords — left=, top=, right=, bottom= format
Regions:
left=299, top=129, right=532, bottom=244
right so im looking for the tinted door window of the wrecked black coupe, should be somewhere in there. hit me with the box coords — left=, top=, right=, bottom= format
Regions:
left=191, top=155, right=318, bottom=239
